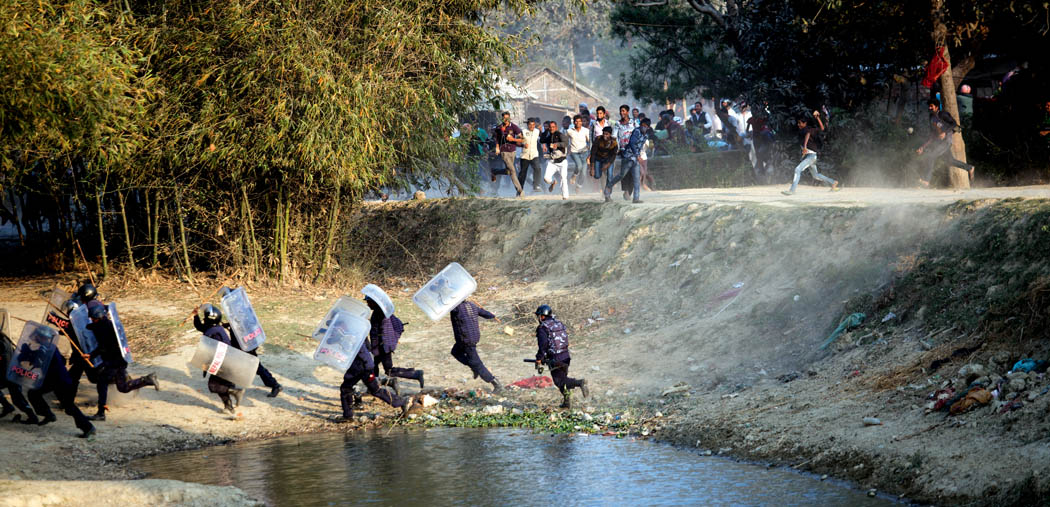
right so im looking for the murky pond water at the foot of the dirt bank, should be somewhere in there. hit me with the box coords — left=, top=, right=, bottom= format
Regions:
left=132, top=428, right=890, bottom=506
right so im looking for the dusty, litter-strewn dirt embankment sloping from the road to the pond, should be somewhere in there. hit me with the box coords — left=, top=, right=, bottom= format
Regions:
left=0, top=189, right=1050, bottom=503
